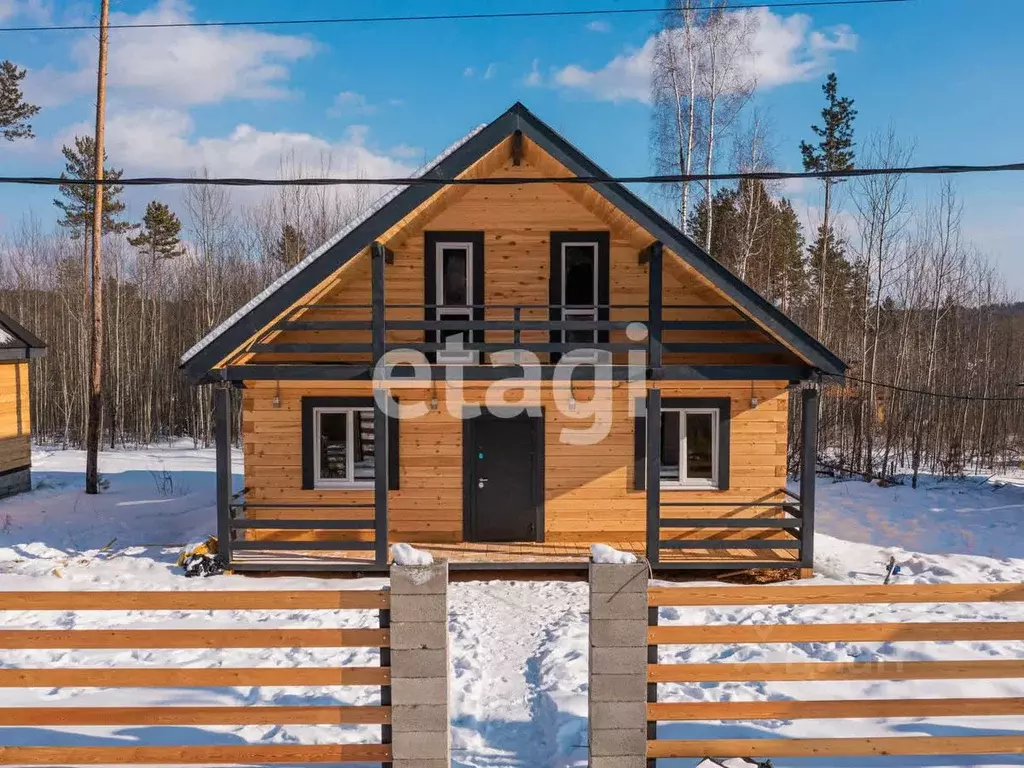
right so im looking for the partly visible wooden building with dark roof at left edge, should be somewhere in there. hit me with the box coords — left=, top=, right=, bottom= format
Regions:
left=0, top=312, right=46, bottom=498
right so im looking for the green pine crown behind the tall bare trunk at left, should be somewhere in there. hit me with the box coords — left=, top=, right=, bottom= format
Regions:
left=53, top=136, right=131, bottom=239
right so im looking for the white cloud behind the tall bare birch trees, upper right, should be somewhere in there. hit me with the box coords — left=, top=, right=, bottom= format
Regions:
left=552, top=8, right=857, bottom=103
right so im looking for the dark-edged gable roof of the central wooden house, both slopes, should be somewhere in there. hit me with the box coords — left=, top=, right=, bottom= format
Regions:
left=181, top=101, right=846, bottom=380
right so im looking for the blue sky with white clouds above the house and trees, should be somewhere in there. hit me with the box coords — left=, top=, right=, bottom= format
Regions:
left=0, top=0, right=1024, bottom=290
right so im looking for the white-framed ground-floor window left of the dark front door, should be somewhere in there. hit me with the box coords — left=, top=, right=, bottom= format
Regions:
left=313, top=408, right=374, bottom=488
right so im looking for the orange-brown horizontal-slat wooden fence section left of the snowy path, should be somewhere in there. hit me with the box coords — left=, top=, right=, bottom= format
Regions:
left=0, top=590, right=391, bottom=765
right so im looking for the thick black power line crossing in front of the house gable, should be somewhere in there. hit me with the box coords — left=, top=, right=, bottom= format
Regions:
left=6, top=163, right=1024, bottom=186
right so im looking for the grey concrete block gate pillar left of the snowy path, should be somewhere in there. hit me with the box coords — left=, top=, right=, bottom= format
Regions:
left=391, top=561, right=452, bottom=768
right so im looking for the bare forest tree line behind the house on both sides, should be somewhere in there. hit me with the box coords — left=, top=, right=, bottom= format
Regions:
left=0, top=9, right=1024, bottom=487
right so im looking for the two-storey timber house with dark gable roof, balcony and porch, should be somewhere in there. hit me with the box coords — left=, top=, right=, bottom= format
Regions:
left=182, top=103, right=845, bottom=570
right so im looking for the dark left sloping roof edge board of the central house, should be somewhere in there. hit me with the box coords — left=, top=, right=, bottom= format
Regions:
left=180, top=110, right=515, bottom=383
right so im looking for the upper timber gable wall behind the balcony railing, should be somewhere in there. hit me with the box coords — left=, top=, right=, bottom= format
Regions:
left=249, top=139, right=800, bottom=365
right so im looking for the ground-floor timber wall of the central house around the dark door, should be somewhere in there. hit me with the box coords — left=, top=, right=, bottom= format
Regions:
left=242, top=381, right=788, bottom=543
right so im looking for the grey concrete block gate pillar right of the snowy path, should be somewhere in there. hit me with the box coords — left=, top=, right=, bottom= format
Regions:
left=589, top=562, right=649, bottom=768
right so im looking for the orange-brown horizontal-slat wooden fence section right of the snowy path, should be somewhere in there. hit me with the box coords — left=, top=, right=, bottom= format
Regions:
left=647, top=584, right=1024, bottom=764
